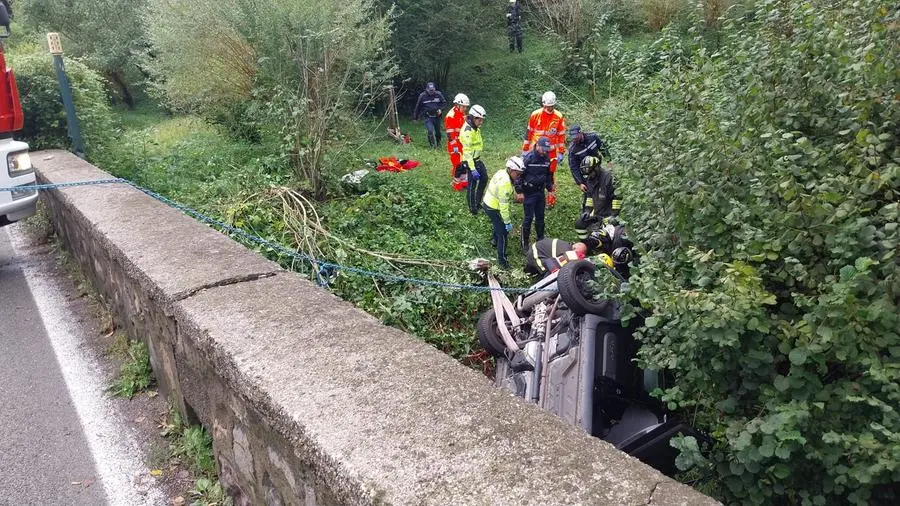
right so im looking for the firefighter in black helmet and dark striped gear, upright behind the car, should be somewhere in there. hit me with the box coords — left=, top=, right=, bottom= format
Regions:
left=575, top=156, right=622, bottom=240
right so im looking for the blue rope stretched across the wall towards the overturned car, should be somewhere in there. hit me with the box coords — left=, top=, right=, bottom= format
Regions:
left=0, top=178, right=555, bottom=293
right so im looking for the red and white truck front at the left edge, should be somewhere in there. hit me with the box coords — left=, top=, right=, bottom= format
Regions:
left=0, top=0, right=38, bottom=227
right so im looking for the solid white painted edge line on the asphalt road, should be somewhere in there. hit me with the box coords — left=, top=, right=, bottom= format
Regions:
left=4, top=226, right=168, bottom=506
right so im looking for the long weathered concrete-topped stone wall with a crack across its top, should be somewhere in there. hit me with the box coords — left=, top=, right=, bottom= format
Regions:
left=32, top=151, right=716, bottom=506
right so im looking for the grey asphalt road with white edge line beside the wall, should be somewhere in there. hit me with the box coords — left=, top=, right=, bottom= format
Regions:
left=0, top=224, right=168, bottom=506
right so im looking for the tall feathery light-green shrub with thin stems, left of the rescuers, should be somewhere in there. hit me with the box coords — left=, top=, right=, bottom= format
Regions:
left=147, top=0, right=395, bottom=199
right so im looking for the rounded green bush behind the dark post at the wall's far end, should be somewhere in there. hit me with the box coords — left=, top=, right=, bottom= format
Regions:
left=9, top=52, right=115, bottom=156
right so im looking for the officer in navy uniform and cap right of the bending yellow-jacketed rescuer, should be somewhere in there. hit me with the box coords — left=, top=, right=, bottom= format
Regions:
left=516, top=137, right=556, bottom=252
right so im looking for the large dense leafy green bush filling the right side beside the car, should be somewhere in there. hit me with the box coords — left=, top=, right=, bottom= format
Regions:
left=621, top=0, right=900, bottom=505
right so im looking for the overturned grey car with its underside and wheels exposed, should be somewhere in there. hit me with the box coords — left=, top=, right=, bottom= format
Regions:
left=478, top=231, right=696, bottom=474
